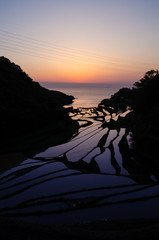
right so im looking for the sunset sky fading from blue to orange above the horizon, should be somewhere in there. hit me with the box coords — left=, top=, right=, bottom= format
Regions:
left=0, top=0, right=159, bottom=83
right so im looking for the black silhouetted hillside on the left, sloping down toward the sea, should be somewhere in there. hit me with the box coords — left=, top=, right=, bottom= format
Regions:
left=0, top=57, right=76, bottom=153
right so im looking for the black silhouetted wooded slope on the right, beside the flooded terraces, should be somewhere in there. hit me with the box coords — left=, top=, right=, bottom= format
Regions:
left=99, top=70, right=159, bottom=173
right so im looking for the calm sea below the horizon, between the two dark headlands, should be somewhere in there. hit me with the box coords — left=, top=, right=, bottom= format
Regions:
left=41, top=82, right=131, bottom=108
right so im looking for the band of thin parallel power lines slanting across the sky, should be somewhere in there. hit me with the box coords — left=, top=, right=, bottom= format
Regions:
left=0, top=29, right=157, bottom=69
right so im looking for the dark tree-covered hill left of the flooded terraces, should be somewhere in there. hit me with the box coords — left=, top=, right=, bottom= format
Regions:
left=0, top=57, right=78, bottom=153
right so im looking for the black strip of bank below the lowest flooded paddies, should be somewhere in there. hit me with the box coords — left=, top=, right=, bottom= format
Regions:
left=0, top=218, right=159, bottom=240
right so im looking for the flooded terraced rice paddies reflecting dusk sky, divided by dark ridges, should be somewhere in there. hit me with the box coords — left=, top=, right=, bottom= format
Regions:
left=0, top=108, right=159, bottom=223
